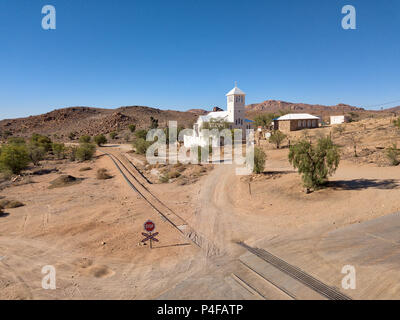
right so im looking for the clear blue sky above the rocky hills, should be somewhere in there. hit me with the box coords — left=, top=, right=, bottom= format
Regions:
left=0, top=0, right=400, bottom=119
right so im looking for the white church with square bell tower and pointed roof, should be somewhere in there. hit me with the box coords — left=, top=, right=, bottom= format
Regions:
left=184, top=83, right=254, bottom=148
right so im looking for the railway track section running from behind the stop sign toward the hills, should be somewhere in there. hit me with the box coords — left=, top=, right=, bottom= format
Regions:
left=100, top=149, right=220, bottom=256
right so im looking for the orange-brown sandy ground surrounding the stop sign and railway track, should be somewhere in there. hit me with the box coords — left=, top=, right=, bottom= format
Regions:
left=0, top=129, right=400, bottom=299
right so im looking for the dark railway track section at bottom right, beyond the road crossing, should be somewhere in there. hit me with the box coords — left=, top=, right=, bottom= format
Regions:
left=238, top=242, right=351, bottom=300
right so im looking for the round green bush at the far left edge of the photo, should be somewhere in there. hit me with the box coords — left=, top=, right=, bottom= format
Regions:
left=0, top=144, right=31, bottom=174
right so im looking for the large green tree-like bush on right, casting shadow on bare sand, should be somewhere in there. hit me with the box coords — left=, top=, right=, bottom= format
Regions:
left=289, top=137, right=340, bottom=189
